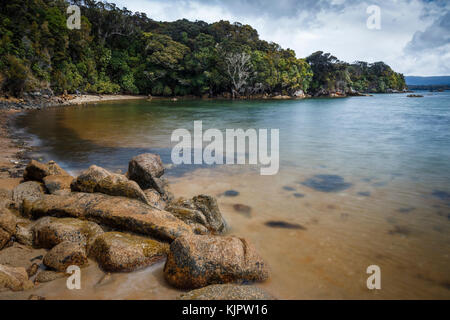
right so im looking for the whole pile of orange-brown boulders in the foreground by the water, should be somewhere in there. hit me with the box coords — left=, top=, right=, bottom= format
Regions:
left=0, top=154, right=269, bottom=299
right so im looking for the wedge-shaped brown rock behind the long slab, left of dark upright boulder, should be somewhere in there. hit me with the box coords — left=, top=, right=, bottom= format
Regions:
left=71, top=165, right=148, bottom=203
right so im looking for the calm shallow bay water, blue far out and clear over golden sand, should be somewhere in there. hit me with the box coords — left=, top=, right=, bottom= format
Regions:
left=6, top=92, right=450, bottom=299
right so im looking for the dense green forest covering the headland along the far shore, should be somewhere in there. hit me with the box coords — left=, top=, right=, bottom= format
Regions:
left=0, top=0, right=404, bottom=96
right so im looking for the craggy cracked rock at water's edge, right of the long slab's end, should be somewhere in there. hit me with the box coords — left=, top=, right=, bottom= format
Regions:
left=166, top=195, right=227, bottom=234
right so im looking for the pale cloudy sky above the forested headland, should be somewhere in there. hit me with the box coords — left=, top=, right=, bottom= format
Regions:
left=113, top=0, right=450, bottom=76
